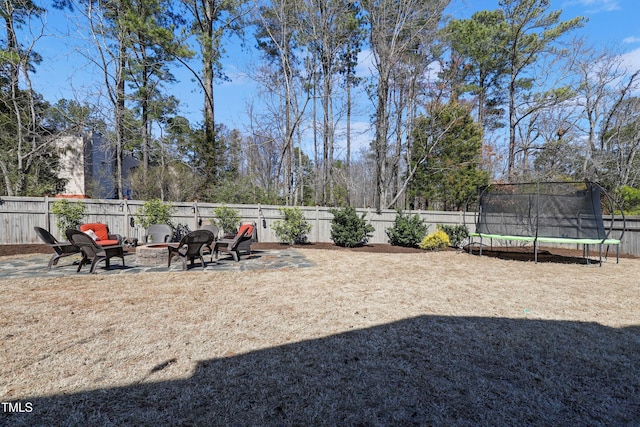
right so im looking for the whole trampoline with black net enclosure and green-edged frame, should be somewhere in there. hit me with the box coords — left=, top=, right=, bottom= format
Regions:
left=469, top=181, right=625, bottom=265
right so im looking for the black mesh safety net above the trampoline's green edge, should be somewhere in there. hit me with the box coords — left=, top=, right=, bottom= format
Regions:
left=476, top=182, right=607, bottom=239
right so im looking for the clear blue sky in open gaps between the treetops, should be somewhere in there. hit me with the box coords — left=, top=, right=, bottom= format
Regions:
left=33, top=0, right=640, bottom=155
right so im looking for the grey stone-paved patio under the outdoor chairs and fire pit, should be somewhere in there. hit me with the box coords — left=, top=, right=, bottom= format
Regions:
left=0, top=249, right=315, bottom=280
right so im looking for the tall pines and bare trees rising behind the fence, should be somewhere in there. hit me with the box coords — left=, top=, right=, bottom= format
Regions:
left=5, top=0, right=640, bottom=214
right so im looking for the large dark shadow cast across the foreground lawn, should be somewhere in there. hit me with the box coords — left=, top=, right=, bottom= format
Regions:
left=0, top=316, right=640, bottom=426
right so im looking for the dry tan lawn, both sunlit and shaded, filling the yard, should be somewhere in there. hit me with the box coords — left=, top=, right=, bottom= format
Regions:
left=0, top=249, right=640, bottom=426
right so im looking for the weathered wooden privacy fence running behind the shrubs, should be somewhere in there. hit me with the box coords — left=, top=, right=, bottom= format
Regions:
left=0, top=196, right=640, bottom=256
